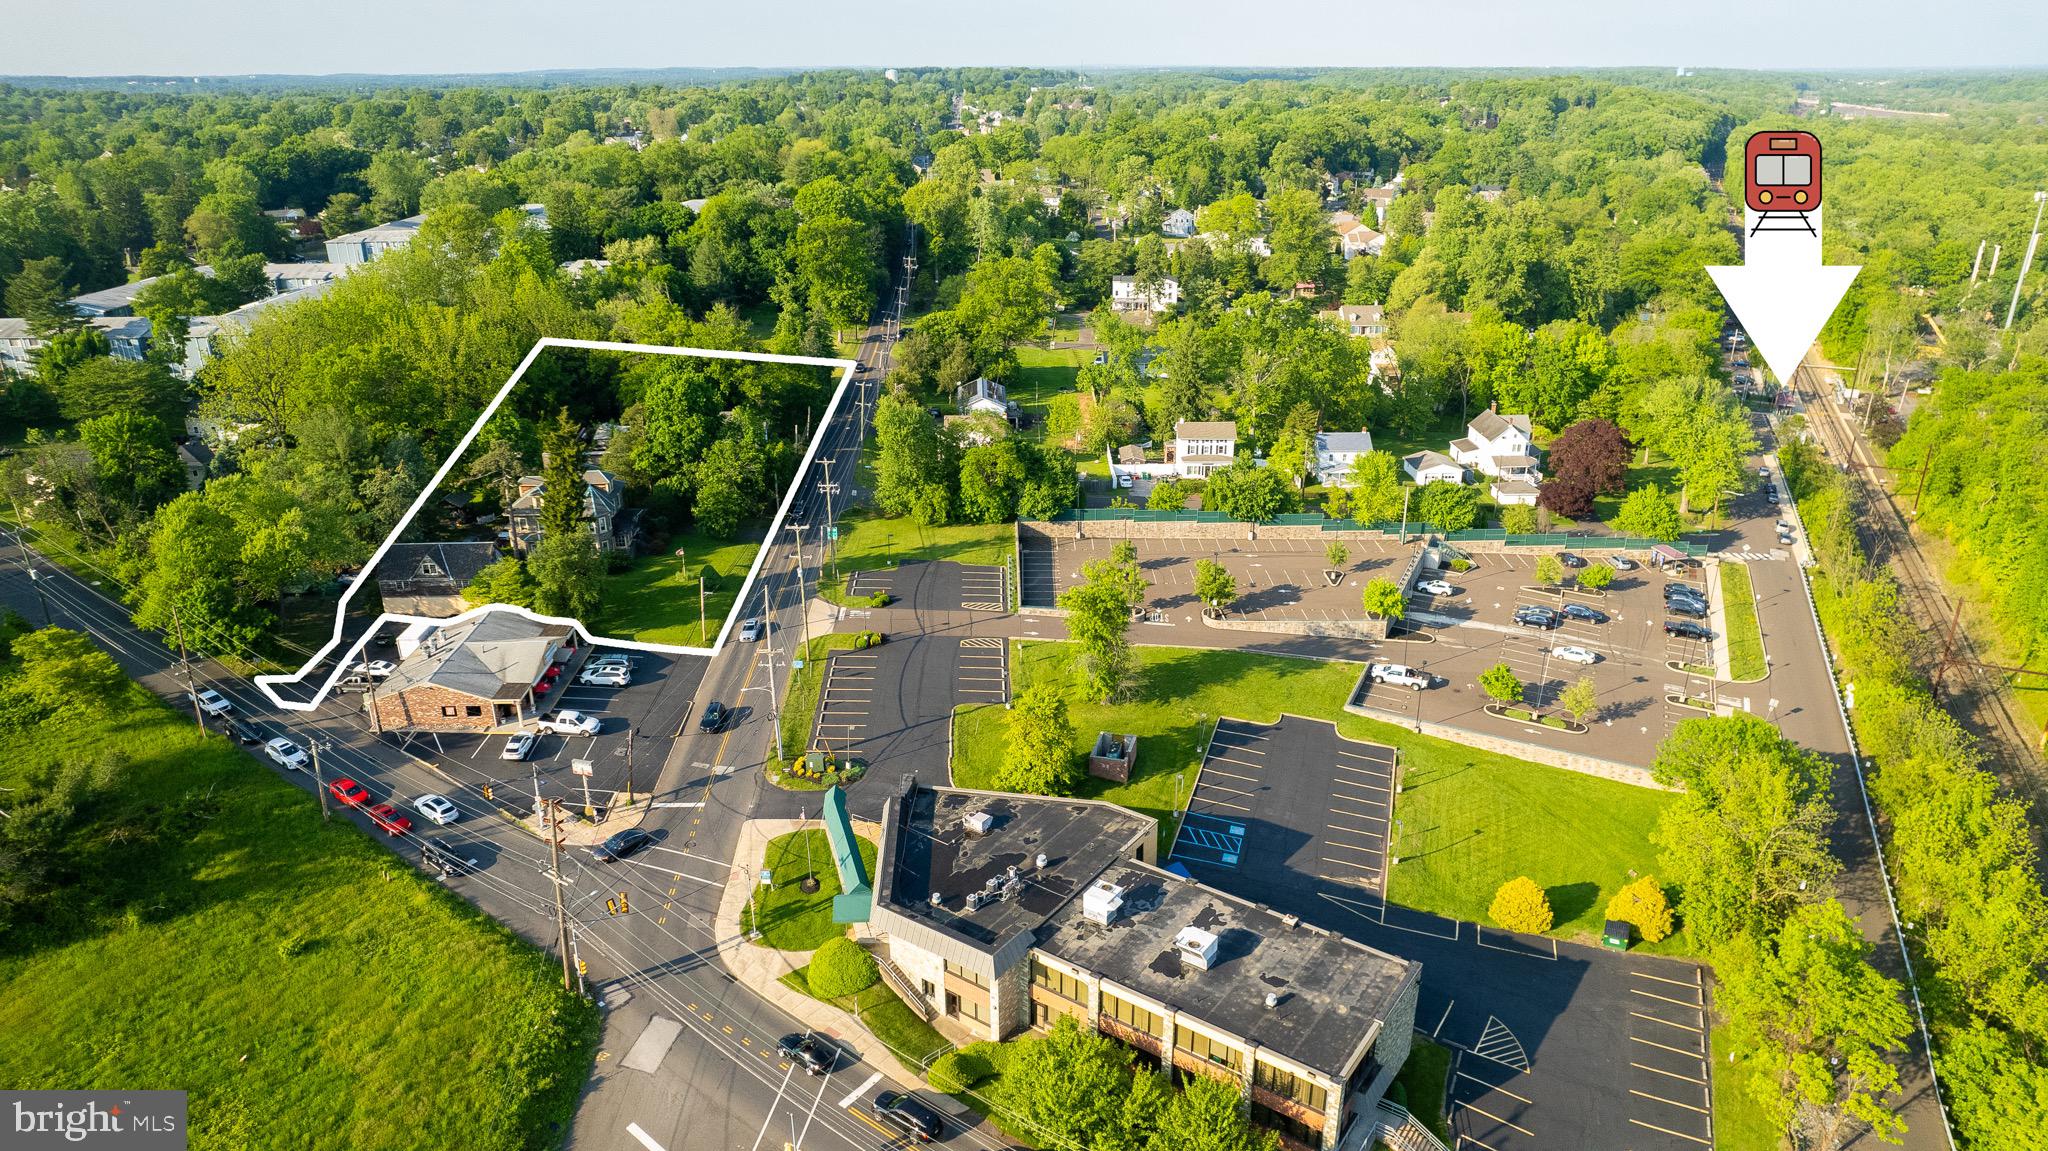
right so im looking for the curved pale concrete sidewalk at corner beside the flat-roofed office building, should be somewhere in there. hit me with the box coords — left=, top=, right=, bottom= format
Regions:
left=711, top=819, right=956, bottom=1089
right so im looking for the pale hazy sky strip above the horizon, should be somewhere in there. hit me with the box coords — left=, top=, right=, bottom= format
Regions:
left=0, top=0, right=2048, bottom=76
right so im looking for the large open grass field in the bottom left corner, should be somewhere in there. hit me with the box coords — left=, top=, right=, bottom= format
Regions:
left=0, top=651, right=598, bottom=1151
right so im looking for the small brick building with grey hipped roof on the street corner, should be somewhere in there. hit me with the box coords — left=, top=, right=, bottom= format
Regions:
left=365, top=610, right=575, bottom=731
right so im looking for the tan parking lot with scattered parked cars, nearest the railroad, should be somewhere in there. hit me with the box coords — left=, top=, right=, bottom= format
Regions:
left=1354, top=553, right=1736, bottom=766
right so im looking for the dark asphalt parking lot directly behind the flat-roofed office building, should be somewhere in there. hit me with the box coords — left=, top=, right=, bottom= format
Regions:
left=1171, top=717, right=1712, bottom=1151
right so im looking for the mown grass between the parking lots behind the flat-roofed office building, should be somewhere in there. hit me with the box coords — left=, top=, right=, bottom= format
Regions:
left=952, top=641, right=1690, bottom=952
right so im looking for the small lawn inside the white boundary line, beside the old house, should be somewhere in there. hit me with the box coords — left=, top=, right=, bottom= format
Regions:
left=590, top=535, right=760, bottom=647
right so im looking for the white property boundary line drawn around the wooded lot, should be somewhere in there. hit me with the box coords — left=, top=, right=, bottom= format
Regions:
left=256, top=336, right=858, bottom=711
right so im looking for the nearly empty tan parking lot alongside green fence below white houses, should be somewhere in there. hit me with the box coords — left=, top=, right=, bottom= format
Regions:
left=1020, top=539, right=1421, bottom=623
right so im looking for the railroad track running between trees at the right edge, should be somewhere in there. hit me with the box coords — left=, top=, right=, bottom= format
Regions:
left=1794, top=352, right=2048, bottom=786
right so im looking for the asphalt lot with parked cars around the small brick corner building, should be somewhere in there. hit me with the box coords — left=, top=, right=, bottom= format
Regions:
left=389, top=645, right=704, bottom=813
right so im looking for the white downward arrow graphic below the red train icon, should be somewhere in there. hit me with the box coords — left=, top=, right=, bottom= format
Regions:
left=1706, top=207, right=1864, bottom=383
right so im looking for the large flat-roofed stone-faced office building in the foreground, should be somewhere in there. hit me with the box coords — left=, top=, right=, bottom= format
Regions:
left=868, top=782, right=1421, bottom=1149
